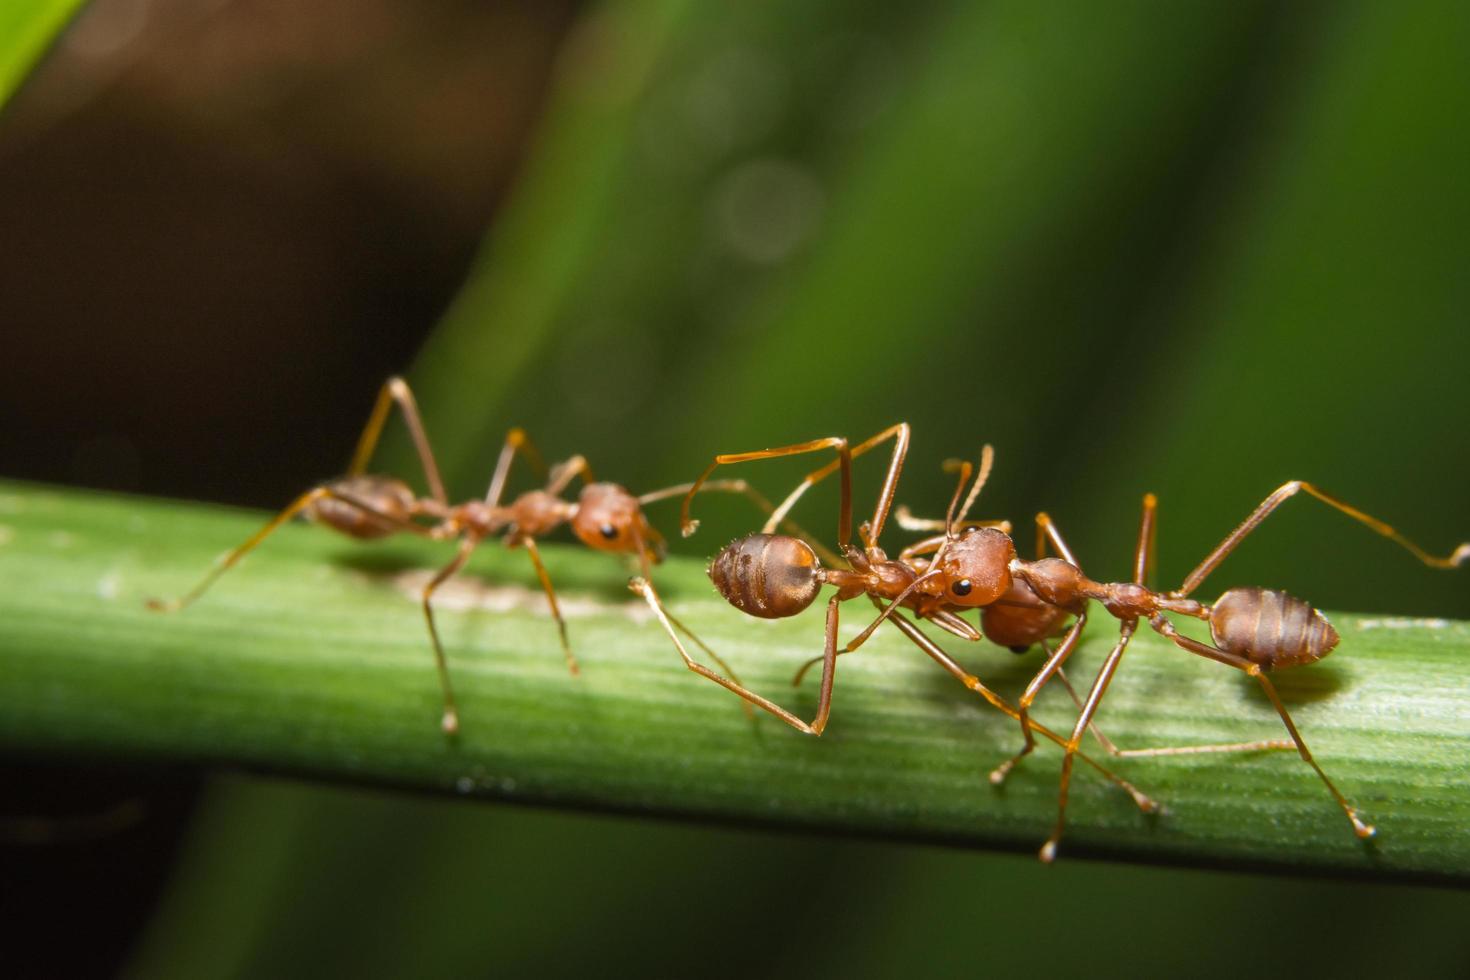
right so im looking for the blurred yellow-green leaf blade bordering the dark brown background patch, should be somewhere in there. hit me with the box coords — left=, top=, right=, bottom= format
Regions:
left=400, top=0, right=688, bottom=482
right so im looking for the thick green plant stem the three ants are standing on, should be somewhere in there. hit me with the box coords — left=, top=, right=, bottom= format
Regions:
left=0, top=483, right=1470, bottom=883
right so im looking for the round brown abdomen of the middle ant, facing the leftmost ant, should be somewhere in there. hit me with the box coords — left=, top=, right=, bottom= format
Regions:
left=709, top=533, right=822, bottom=619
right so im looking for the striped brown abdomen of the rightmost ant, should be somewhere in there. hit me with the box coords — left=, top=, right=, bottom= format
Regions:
left=1210, top=588, right=1338, bottom=670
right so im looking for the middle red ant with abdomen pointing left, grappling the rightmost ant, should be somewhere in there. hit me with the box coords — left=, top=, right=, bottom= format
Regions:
left=632, top=423, right=1157, bottom=813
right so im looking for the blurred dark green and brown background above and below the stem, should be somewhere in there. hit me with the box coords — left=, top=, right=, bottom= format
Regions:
left=0, top=0, right=1470, bottom=977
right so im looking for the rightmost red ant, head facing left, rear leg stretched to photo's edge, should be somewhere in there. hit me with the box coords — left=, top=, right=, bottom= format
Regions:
left=900, top=447, right=1470, bottom=861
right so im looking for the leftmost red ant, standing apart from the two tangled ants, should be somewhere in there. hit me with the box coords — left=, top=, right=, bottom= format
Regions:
left=148, top=378, right=772, bottom=735
